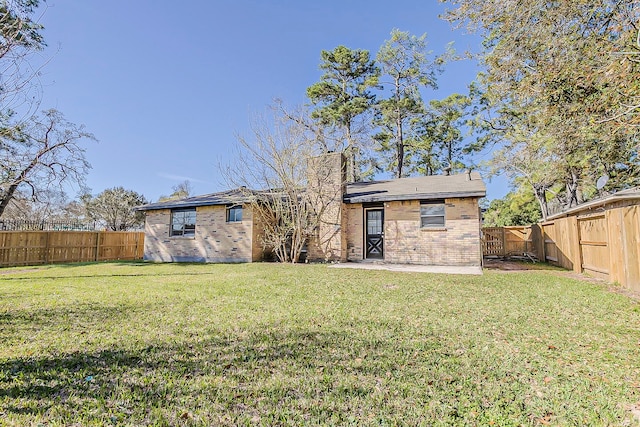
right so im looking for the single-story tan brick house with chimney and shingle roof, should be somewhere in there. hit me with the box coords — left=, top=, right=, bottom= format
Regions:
left=139, top=153, right=486, bottom=266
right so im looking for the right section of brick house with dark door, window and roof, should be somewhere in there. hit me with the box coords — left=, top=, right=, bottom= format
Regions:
left=309, top=154, right=486, bottom=266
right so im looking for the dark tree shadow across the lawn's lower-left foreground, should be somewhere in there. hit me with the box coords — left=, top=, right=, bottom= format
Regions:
left=0, top=330, right=450, bottom=424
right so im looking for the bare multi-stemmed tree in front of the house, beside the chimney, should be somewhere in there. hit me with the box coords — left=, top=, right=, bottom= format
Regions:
left=223, top=104, right=341, bottom=262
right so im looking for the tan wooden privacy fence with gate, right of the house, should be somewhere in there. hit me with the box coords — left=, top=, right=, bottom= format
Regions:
left=482, top=205, right=640, bottom=291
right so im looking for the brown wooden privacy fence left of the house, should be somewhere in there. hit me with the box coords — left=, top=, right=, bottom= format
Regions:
left=0, top=231, right=144, bottom=267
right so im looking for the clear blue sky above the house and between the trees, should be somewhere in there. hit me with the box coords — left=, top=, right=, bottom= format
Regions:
left=40, top=0, right=507, bottom=201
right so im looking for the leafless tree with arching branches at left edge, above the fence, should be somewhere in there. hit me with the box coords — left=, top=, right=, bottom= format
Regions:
left=0, top=110, right=95, bottom=217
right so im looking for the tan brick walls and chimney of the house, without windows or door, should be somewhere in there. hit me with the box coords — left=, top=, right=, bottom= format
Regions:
left=144, top=153, right=482, bottom=266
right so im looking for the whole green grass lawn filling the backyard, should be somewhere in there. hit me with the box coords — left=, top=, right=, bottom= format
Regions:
left=0, top=262, right=640, bottom=426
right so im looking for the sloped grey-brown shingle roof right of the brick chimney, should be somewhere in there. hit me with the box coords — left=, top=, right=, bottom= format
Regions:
left=343, top=172, right=487, bottom=203
